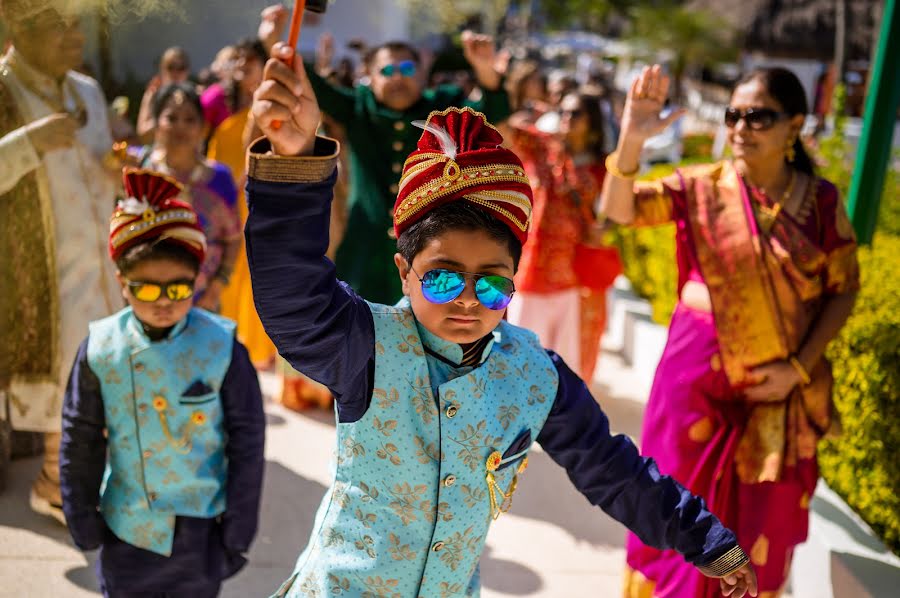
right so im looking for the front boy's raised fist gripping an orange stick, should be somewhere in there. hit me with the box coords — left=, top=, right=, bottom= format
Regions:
left=251, top=42, right=321, bottom=156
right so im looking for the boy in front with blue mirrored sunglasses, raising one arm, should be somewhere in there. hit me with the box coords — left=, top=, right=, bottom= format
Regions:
left=246, top=44, right=756, bottom=598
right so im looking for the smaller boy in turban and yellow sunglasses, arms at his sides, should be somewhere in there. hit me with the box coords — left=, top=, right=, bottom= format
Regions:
left=60, top=170, right=265, bottom=598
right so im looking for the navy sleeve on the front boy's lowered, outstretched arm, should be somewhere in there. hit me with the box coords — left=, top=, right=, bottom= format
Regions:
left=537, top=351, right=737, bottom=566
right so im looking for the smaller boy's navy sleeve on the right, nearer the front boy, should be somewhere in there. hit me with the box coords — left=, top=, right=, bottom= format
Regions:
left=220, top=339, right=266, bottom=553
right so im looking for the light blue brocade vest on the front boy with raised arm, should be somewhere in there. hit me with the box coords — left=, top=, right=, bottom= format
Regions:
left=276, top=304, right=558, bottom=598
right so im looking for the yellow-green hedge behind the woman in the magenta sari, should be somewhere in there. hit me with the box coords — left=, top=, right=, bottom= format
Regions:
left=609, top=161, right=900, bottom=554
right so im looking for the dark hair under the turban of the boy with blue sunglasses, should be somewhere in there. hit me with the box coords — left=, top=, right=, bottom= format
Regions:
left=397, top=201, right=522, bottom=271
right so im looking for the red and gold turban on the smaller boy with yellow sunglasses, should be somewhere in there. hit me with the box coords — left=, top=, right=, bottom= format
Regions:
left=109, top=168, right=206, bottom=263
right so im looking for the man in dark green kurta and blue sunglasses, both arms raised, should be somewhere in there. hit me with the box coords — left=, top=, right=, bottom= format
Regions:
left=307, top=32, right=510, bottom=304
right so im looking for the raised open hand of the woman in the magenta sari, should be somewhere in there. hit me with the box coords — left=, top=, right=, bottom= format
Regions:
left=621, top=64, right=684, bottom=141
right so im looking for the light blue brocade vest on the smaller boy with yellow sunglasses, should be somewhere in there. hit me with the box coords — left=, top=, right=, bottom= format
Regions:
left=87, top=308, right=234, bottom=556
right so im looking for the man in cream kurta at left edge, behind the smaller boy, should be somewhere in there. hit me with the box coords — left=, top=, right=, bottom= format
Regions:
left=0, top=0, right=122, bottom=516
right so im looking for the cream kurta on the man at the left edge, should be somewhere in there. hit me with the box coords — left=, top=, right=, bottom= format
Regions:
left=0, top=50, right=123, bottom=432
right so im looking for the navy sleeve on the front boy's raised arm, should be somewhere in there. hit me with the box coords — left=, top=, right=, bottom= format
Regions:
left=244, top=138, right=375, bottom=421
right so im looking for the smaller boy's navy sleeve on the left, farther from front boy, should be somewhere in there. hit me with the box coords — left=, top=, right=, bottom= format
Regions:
left=59, top=339, right=106, bottom=550
